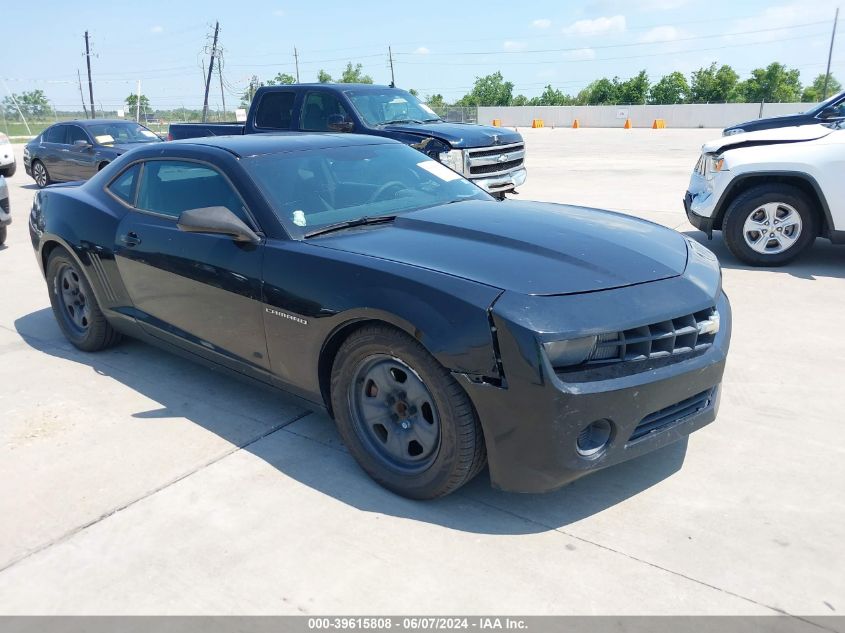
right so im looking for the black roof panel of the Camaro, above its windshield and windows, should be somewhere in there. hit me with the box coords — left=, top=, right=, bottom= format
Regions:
left=169, top=132, right=401, bottom=157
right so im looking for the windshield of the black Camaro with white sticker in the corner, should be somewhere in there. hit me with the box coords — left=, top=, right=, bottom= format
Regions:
left=242, top=144, right=492, bottom=238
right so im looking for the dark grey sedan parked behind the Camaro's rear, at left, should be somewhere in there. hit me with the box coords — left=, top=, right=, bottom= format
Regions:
left=23, top=119, right=161, bottom=187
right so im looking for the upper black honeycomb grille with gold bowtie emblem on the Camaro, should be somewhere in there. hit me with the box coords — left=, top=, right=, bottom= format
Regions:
left=586, top=308, right=718, bottom=364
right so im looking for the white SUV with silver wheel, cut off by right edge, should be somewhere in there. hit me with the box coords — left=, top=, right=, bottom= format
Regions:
left=684, top=125, right=845, bottom=266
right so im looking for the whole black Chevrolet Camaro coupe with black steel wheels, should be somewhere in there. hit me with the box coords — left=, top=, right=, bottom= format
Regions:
left=24, top=134, right=730, bottom=498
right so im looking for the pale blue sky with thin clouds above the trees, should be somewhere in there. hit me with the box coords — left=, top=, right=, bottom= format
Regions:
left=0, top=0, right=845, bottom=109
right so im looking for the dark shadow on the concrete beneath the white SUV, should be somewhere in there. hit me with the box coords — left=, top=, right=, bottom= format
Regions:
left=683, top=230, right=845, bottom=280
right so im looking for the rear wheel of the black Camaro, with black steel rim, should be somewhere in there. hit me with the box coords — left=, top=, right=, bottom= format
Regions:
left=47, top=248, right=122, bottom=352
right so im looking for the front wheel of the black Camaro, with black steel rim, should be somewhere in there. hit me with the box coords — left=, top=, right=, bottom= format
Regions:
left=331, top=325, right=487, bottom=499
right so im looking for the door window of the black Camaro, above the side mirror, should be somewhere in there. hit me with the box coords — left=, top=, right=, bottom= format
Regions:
left=135, top=160, right=251, bottom=224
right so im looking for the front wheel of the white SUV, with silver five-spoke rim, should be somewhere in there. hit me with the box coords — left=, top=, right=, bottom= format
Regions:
left=722, top=183, right=819, bottom=266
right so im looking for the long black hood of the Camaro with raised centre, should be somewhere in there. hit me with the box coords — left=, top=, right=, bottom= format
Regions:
left=311, top=200, right=687, bottom=295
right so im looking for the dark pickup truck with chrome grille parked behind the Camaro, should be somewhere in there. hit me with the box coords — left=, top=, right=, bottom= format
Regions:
left=168, top=84, right=526, bottom=197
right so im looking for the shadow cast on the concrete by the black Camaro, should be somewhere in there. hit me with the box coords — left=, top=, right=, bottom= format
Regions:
left=15, top=308, right=687, bottom=534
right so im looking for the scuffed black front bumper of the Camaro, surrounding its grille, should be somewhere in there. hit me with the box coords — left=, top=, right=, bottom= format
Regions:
left=462, top=280, right=731, bottom=493
